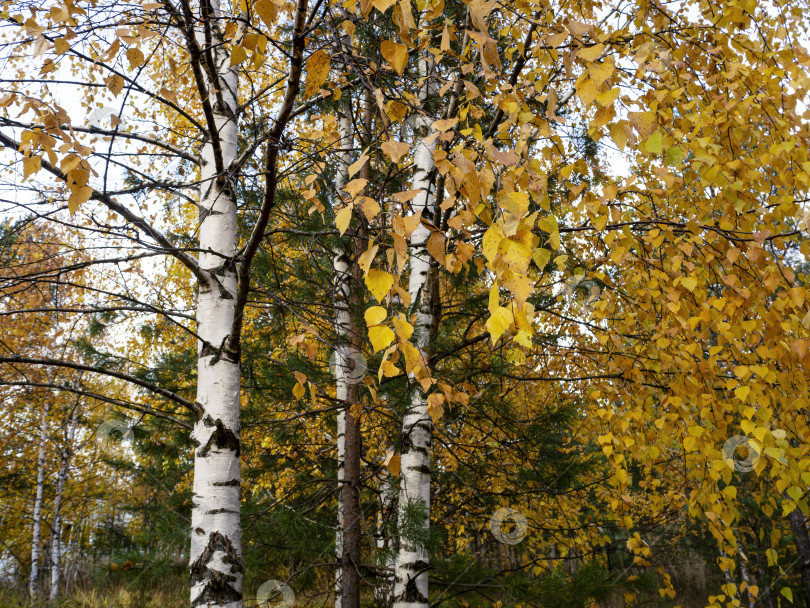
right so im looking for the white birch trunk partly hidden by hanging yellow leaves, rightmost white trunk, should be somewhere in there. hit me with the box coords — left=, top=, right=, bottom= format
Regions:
left=394, top=53, right=436, bottom=608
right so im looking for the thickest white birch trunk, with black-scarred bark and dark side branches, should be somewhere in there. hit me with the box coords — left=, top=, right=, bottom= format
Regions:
left=189, top=5, right=243, bottom=608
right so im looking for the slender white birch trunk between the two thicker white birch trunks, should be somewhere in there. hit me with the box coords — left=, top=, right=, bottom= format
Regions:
left=332, top=86, right=353, bottom=608
